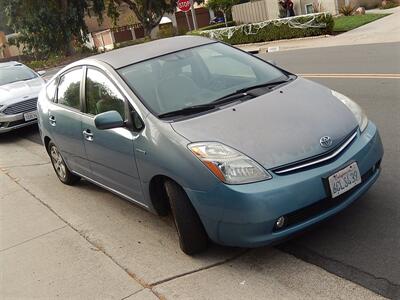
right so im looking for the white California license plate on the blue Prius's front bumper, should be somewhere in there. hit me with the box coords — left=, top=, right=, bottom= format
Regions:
left=328, top=162, right=361, bottom=198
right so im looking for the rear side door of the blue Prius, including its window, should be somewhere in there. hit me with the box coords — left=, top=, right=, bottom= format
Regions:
left=47, top=67, right=90, bottom=176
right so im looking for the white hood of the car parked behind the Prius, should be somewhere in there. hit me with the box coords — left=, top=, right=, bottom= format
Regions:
left=0, top=77, right=45, bottom=105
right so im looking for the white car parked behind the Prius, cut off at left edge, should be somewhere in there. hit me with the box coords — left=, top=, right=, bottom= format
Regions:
left=0, top=61, right=45, bottom=133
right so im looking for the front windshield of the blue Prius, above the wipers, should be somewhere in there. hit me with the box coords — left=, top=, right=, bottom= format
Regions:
left=118, top=43, right=288, bottom=116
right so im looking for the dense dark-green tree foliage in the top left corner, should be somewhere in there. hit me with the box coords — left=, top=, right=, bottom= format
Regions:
left=0, top=0, right=105, bottom=56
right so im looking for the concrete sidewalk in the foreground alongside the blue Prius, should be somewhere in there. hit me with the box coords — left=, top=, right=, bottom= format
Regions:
left=0, top=138, right=380, bottom=299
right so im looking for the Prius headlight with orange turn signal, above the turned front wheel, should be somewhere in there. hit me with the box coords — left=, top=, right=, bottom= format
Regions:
left=188, top=142, right=272, bottom=184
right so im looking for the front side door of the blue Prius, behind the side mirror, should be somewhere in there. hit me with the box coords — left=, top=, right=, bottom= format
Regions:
left=82, top=67, right=143, bottom=201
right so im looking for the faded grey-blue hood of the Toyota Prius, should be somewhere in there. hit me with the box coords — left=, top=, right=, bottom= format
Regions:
left=171, top=78, right=358, bottom=169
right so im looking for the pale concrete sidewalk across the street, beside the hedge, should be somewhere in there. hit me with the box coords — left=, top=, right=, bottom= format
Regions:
left=236, top=7, right=400, bottom=53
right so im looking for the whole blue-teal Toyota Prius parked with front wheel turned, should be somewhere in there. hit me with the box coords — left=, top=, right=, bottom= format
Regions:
left=38, top=36, right=383, bottom=254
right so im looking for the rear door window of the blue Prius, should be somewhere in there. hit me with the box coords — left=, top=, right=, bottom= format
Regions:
left=57, top=69, right=82, bottom=110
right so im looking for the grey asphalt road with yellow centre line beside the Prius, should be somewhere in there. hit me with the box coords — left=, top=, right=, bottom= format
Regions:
left=3, top=43, right=400, bottom=299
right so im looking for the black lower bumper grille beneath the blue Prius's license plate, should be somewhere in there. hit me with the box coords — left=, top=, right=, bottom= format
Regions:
left=273, top=165, right=380, bottom=232
